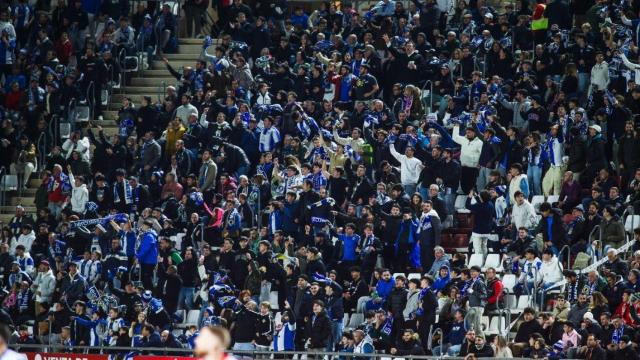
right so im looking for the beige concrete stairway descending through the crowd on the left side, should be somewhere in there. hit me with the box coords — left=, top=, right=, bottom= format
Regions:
left=0, top=38, right=203, bottom=222
